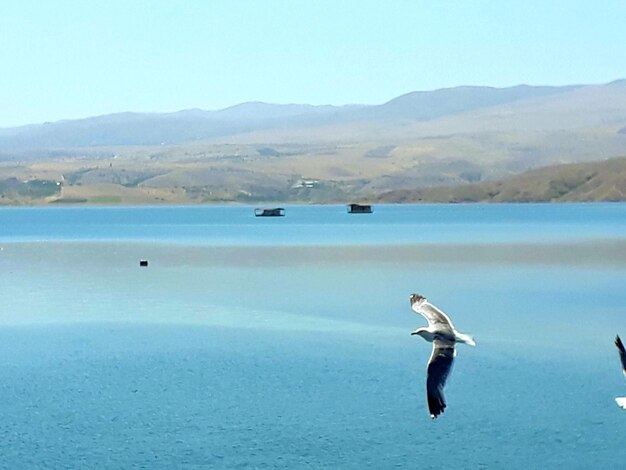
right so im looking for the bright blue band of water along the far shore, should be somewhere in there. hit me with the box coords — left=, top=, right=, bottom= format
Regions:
left=0, top=204, right=626, bottom=245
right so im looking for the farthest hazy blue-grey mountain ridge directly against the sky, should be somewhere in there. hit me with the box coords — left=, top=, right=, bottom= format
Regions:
left=0, top=81, right=608, bottom=152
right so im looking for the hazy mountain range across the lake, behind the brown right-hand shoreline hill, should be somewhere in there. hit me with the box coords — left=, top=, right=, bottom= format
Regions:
left=0, top=80, right=626, bottom=203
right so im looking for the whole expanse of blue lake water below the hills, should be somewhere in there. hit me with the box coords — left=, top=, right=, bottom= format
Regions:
left=0, top=204, right=626, bottom=468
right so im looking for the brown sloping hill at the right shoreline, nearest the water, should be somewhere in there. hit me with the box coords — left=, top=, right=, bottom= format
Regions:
left=377, top=157, right=626, bottom=203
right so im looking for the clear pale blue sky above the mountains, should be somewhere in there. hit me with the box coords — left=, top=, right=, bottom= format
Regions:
left=0, top=0, right=626, bottom=127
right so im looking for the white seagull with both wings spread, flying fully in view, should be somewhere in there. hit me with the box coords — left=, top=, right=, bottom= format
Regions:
left=410, top=294, right=476, bottom=419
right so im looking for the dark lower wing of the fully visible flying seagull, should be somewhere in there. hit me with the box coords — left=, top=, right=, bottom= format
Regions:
left=426, top=339, right=455, bottom=419
